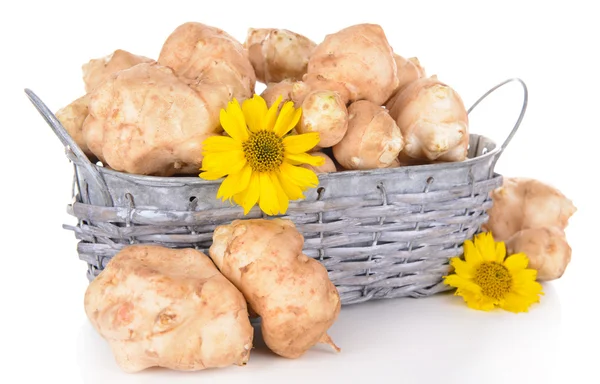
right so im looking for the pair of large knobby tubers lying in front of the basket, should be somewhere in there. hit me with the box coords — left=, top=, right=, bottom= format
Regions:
left=84, top=219, right=341, bottom=373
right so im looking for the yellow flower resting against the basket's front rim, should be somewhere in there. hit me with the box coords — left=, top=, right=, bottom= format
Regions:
left=200, top=95, right=324, bottom=215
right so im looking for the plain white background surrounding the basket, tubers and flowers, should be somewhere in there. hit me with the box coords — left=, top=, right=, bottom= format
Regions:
left=0, top=0, right=600, bottom=384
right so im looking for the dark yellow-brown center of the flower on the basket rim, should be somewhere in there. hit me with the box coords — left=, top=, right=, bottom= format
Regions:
left=242, top=131, right=283, bottom=172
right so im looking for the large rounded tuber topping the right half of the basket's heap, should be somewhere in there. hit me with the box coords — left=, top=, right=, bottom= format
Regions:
left=303, top=24, right=398, bottom=105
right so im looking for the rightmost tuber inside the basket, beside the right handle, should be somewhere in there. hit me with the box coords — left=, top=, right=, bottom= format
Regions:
left=389, top=76, right=469, bottom=161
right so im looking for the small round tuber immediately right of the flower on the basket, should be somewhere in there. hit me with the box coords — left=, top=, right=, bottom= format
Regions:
left=296, top=91, right=348, bottom=148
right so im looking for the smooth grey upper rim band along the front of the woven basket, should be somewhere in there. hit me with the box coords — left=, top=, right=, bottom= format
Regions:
left=81, top=133, right=502, bottom=185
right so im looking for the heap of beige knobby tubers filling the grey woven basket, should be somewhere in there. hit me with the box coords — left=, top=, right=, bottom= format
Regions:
left=56, top=22, right=469, bottom=176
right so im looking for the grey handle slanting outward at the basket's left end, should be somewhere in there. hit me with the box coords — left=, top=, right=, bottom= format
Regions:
left=25, top=88, right=113, bottom=207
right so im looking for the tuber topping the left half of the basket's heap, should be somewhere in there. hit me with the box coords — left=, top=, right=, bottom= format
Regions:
left=158, top=22, right=256, bottom=102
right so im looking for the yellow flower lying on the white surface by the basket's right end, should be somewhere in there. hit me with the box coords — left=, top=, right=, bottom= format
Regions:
left=444, top=232, right=544, bottom=313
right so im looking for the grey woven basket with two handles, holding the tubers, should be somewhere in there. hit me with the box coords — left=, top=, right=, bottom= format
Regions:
left=25, top=79, right=527, bottom=305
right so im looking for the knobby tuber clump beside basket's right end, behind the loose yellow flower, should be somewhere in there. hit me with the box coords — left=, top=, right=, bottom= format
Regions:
left=482, top=177, right=577, bottom=280
